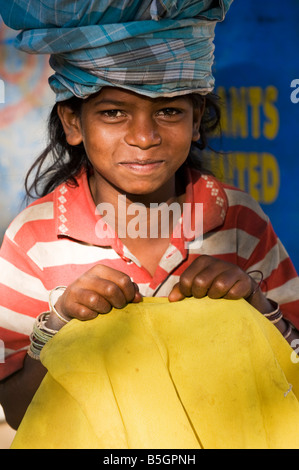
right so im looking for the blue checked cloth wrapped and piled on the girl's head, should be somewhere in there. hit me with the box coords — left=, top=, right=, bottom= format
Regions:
left=0, top=0, right=233, bottom=101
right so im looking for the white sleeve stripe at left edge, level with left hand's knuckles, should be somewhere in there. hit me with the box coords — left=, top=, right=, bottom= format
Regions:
left=0, top=258, right=49, bottom=301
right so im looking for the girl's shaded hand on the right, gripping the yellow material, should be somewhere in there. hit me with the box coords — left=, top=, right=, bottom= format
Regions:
left=168, top=255, right=257, bottom=302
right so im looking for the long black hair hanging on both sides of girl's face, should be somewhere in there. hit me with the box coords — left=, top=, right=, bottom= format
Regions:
left=25, top=93, right=221, bottom=200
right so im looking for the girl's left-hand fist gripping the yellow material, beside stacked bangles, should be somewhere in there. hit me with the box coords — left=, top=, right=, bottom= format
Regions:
left=50, top=264, right=142, bottom=320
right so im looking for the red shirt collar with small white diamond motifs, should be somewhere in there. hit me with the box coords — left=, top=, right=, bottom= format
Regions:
left=54, top=167, right=227, bottom=253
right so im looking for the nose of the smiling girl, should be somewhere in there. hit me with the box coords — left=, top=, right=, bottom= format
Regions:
left=125, top=115, right=162, bottom=150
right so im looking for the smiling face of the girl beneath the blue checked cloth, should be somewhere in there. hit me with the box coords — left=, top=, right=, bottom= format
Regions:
left=59, top=87, right=202, bottom=203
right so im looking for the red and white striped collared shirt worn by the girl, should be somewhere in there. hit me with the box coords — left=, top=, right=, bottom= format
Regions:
left=0, top=168, right=299, bottom=379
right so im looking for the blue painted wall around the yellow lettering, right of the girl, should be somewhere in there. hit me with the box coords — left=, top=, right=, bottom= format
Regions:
left=213, top=0, right=299, bottom=270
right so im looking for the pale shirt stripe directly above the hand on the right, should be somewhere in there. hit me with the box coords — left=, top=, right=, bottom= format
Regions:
left=189, top=228, right=259, bottom=259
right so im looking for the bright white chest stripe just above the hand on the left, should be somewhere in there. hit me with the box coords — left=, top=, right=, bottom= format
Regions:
left=27, top=240, right=120, bottom=269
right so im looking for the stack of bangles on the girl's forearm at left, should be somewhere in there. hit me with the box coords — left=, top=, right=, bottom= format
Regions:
left=27, top=312, right=57, bottom=360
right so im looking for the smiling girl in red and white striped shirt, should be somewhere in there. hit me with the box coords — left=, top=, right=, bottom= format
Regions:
left=0, top=2, right=299, bottom=448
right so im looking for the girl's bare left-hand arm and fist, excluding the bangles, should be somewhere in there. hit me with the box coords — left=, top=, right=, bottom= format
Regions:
left=0, top=265, right=141, bottom=429
